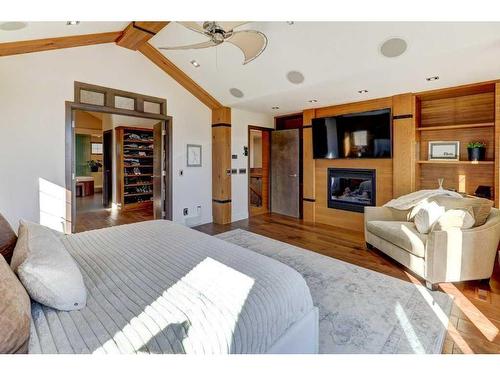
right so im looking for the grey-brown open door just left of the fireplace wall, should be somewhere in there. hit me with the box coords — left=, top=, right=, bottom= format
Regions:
left=271, top=129, right=300, bottom=218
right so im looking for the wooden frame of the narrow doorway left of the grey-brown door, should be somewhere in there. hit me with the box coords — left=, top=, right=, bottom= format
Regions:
left=247, top=125, right=273, bottom=216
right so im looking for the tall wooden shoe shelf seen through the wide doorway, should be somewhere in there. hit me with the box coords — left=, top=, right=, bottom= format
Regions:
left=115, top=126, right=154, bottom=210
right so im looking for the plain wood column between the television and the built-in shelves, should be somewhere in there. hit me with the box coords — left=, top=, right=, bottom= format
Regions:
left=392, top=94, right=418, bottom=198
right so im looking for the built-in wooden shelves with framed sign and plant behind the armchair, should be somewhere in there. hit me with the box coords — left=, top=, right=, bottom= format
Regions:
left=416, top=83, right=499, bottom=206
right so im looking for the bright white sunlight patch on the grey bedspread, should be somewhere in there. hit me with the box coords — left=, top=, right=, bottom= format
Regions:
left=94, top=257, right=255, bottom=354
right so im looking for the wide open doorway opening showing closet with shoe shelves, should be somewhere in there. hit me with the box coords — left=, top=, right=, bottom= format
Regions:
left=74, top=110, right=167, bottom=232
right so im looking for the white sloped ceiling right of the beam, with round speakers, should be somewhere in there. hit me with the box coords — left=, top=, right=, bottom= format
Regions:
left=151, top=22, right=500, bottom=114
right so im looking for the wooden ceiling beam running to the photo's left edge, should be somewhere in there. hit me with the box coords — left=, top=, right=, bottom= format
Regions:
left=0, top=31, right=122, bottom=56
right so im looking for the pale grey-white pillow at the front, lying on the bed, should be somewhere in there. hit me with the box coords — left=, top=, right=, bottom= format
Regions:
left=12, top=220, right=87, bottom=311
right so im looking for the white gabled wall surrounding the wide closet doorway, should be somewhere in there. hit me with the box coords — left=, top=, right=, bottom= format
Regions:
left=0, top=44, right=213, bottom=229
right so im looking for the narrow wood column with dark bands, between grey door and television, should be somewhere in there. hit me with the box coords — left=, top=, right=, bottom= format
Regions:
left=302, top=109, right=316, bottom=223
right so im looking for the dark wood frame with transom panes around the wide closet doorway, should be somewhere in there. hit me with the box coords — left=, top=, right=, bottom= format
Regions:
left=65, top=82, right=172, bottom=233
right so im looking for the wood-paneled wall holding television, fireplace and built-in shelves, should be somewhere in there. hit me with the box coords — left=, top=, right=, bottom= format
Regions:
left=303, top=81, right=500, bottom=230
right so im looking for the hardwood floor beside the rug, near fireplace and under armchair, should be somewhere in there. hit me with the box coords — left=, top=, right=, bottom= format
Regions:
left=195, top=214, right=500, bottom=354
